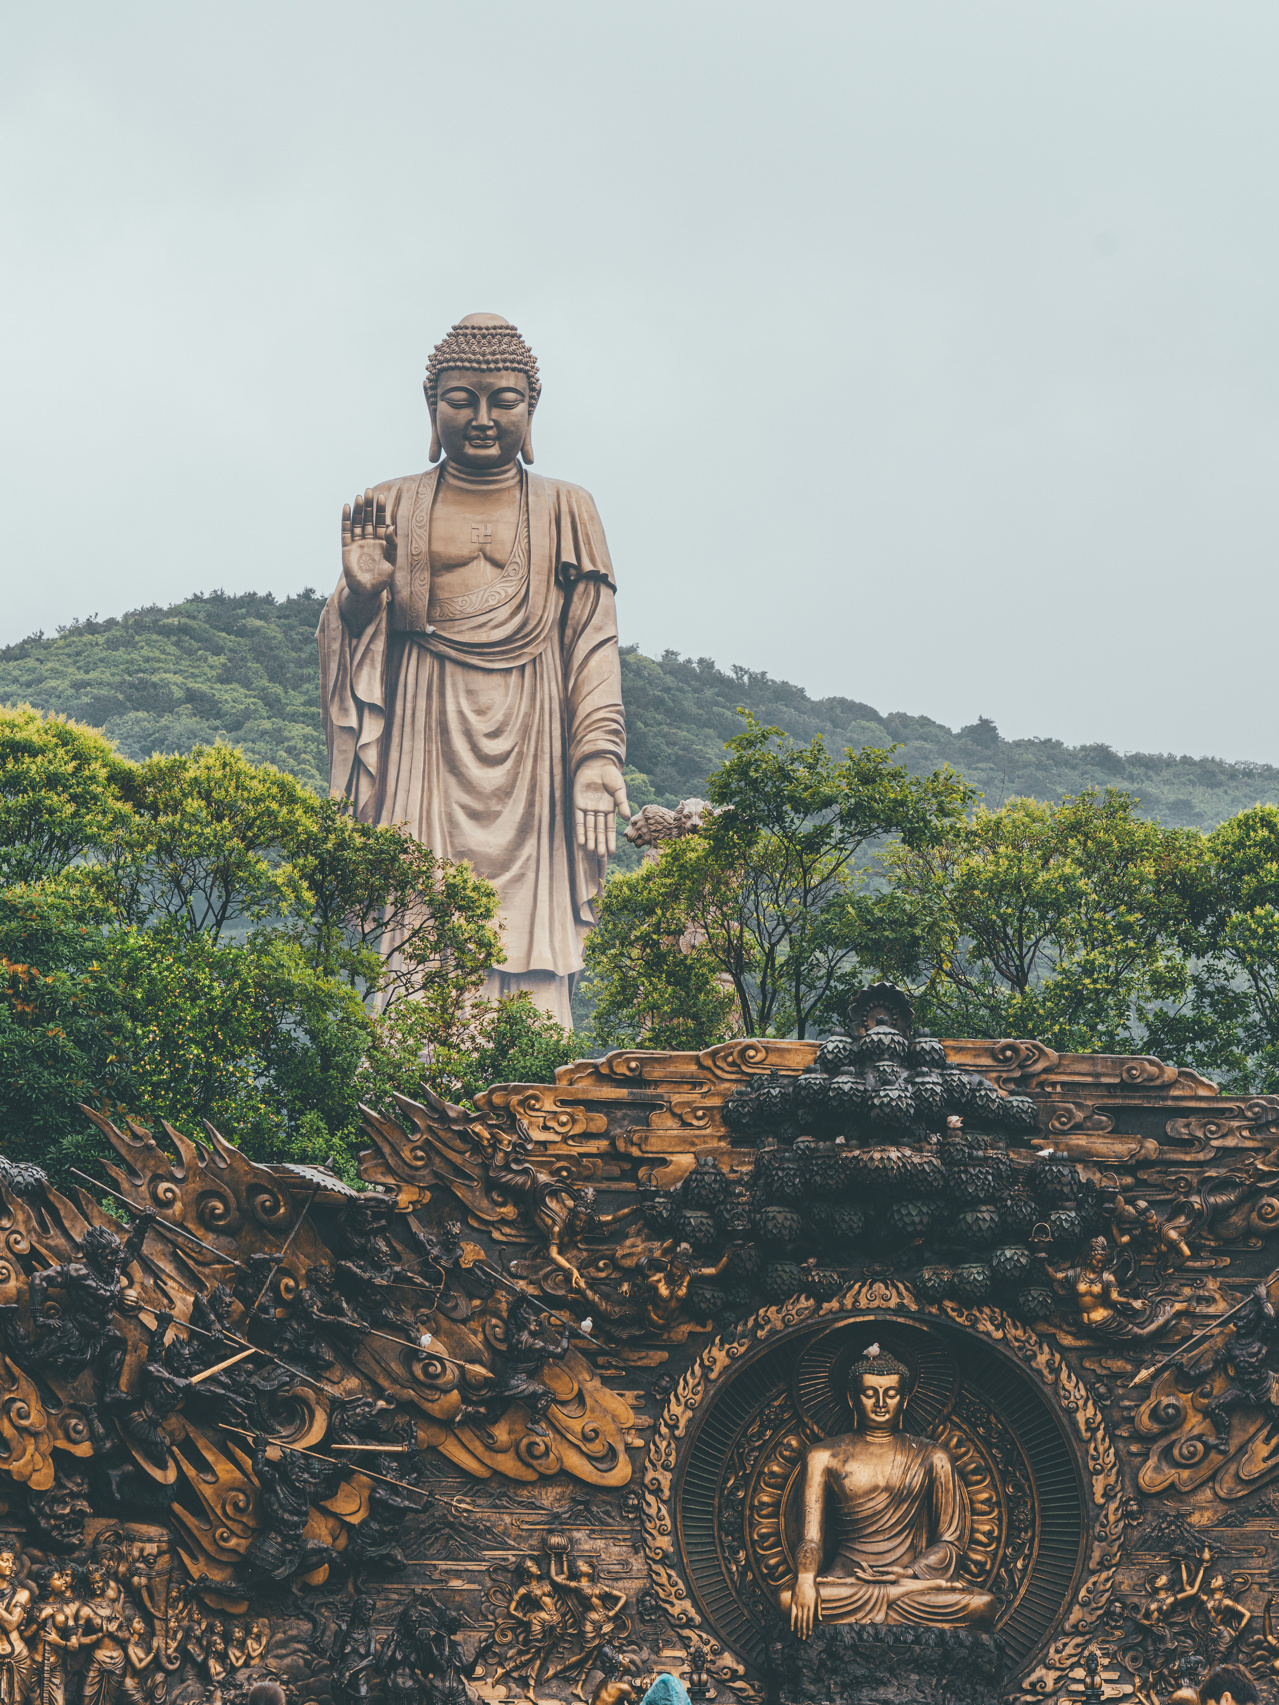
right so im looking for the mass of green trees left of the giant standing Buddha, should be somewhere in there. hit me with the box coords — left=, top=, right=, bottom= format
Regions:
left=0, top=708, right=573, bottom=1178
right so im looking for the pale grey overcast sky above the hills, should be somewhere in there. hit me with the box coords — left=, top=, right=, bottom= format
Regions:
left=0, top=0, right=1279, bottom=762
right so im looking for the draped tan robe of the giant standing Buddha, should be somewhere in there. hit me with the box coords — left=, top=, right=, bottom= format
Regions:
left=317, top=467, right=626, bottom=1025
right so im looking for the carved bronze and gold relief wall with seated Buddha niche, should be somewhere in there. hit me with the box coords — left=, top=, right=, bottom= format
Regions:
left=0, top=991, right=1279, bottom=1705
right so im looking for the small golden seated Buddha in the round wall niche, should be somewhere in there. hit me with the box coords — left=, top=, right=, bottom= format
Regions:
left=781, top=1344, right=998, bottom=1640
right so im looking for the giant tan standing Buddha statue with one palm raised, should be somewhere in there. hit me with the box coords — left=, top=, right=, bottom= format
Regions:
left=319, top=314, right=629, bottom=1025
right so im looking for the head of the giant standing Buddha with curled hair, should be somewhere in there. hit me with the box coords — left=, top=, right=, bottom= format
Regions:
left=423, top=314, right=542, bottom=474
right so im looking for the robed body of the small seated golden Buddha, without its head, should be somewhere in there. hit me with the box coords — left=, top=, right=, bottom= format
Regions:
left=803, top=1432, right=996, bottom=1627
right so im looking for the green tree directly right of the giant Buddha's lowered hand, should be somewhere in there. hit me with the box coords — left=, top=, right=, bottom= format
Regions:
left=587, top=714, right=972, bottom=1047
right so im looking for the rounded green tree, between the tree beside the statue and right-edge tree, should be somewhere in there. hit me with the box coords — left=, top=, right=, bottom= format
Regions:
left=861, top=789, right=1207, bottom=1052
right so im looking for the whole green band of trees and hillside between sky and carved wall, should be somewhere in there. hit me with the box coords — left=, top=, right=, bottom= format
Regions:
left=0, top=590, right=1279, bottom=1091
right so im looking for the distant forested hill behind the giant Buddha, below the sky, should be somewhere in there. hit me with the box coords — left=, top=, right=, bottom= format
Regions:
left=0, top=588, right=1279, bottom=827
